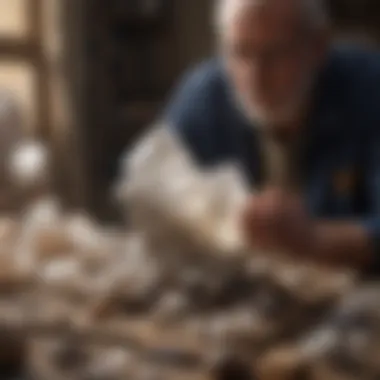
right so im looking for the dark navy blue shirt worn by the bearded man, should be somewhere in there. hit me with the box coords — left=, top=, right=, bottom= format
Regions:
left=165, top=47, right=380, bottom=269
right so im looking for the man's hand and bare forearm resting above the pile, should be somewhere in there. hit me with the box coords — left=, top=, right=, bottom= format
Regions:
left=242, top=189, right=374, bottom=269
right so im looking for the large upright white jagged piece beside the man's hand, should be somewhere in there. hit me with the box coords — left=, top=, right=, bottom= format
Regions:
left=120, top=125, right=248, bottom=253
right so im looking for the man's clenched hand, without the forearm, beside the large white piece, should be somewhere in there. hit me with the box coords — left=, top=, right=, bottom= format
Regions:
left=242, top=189, right=314, bottom=254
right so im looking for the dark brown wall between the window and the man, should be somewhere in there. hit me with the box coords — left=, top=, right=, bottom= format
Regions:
left=76, top=0, right=217, bottom=220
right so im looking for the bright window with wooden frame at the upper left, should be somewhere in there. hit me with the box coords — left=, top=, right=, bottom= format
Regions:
left=0, top=0, right=49, bottom=134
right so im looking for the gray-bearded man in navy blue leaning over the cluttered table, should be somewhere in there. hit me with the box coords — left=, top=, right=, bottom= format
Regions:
left=165, top=0, right=380, bottom=271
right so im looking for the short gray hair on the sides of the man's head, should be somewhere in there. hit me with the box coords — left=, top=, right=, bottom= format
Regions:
left=214, top=0, right=329, bottom=31
